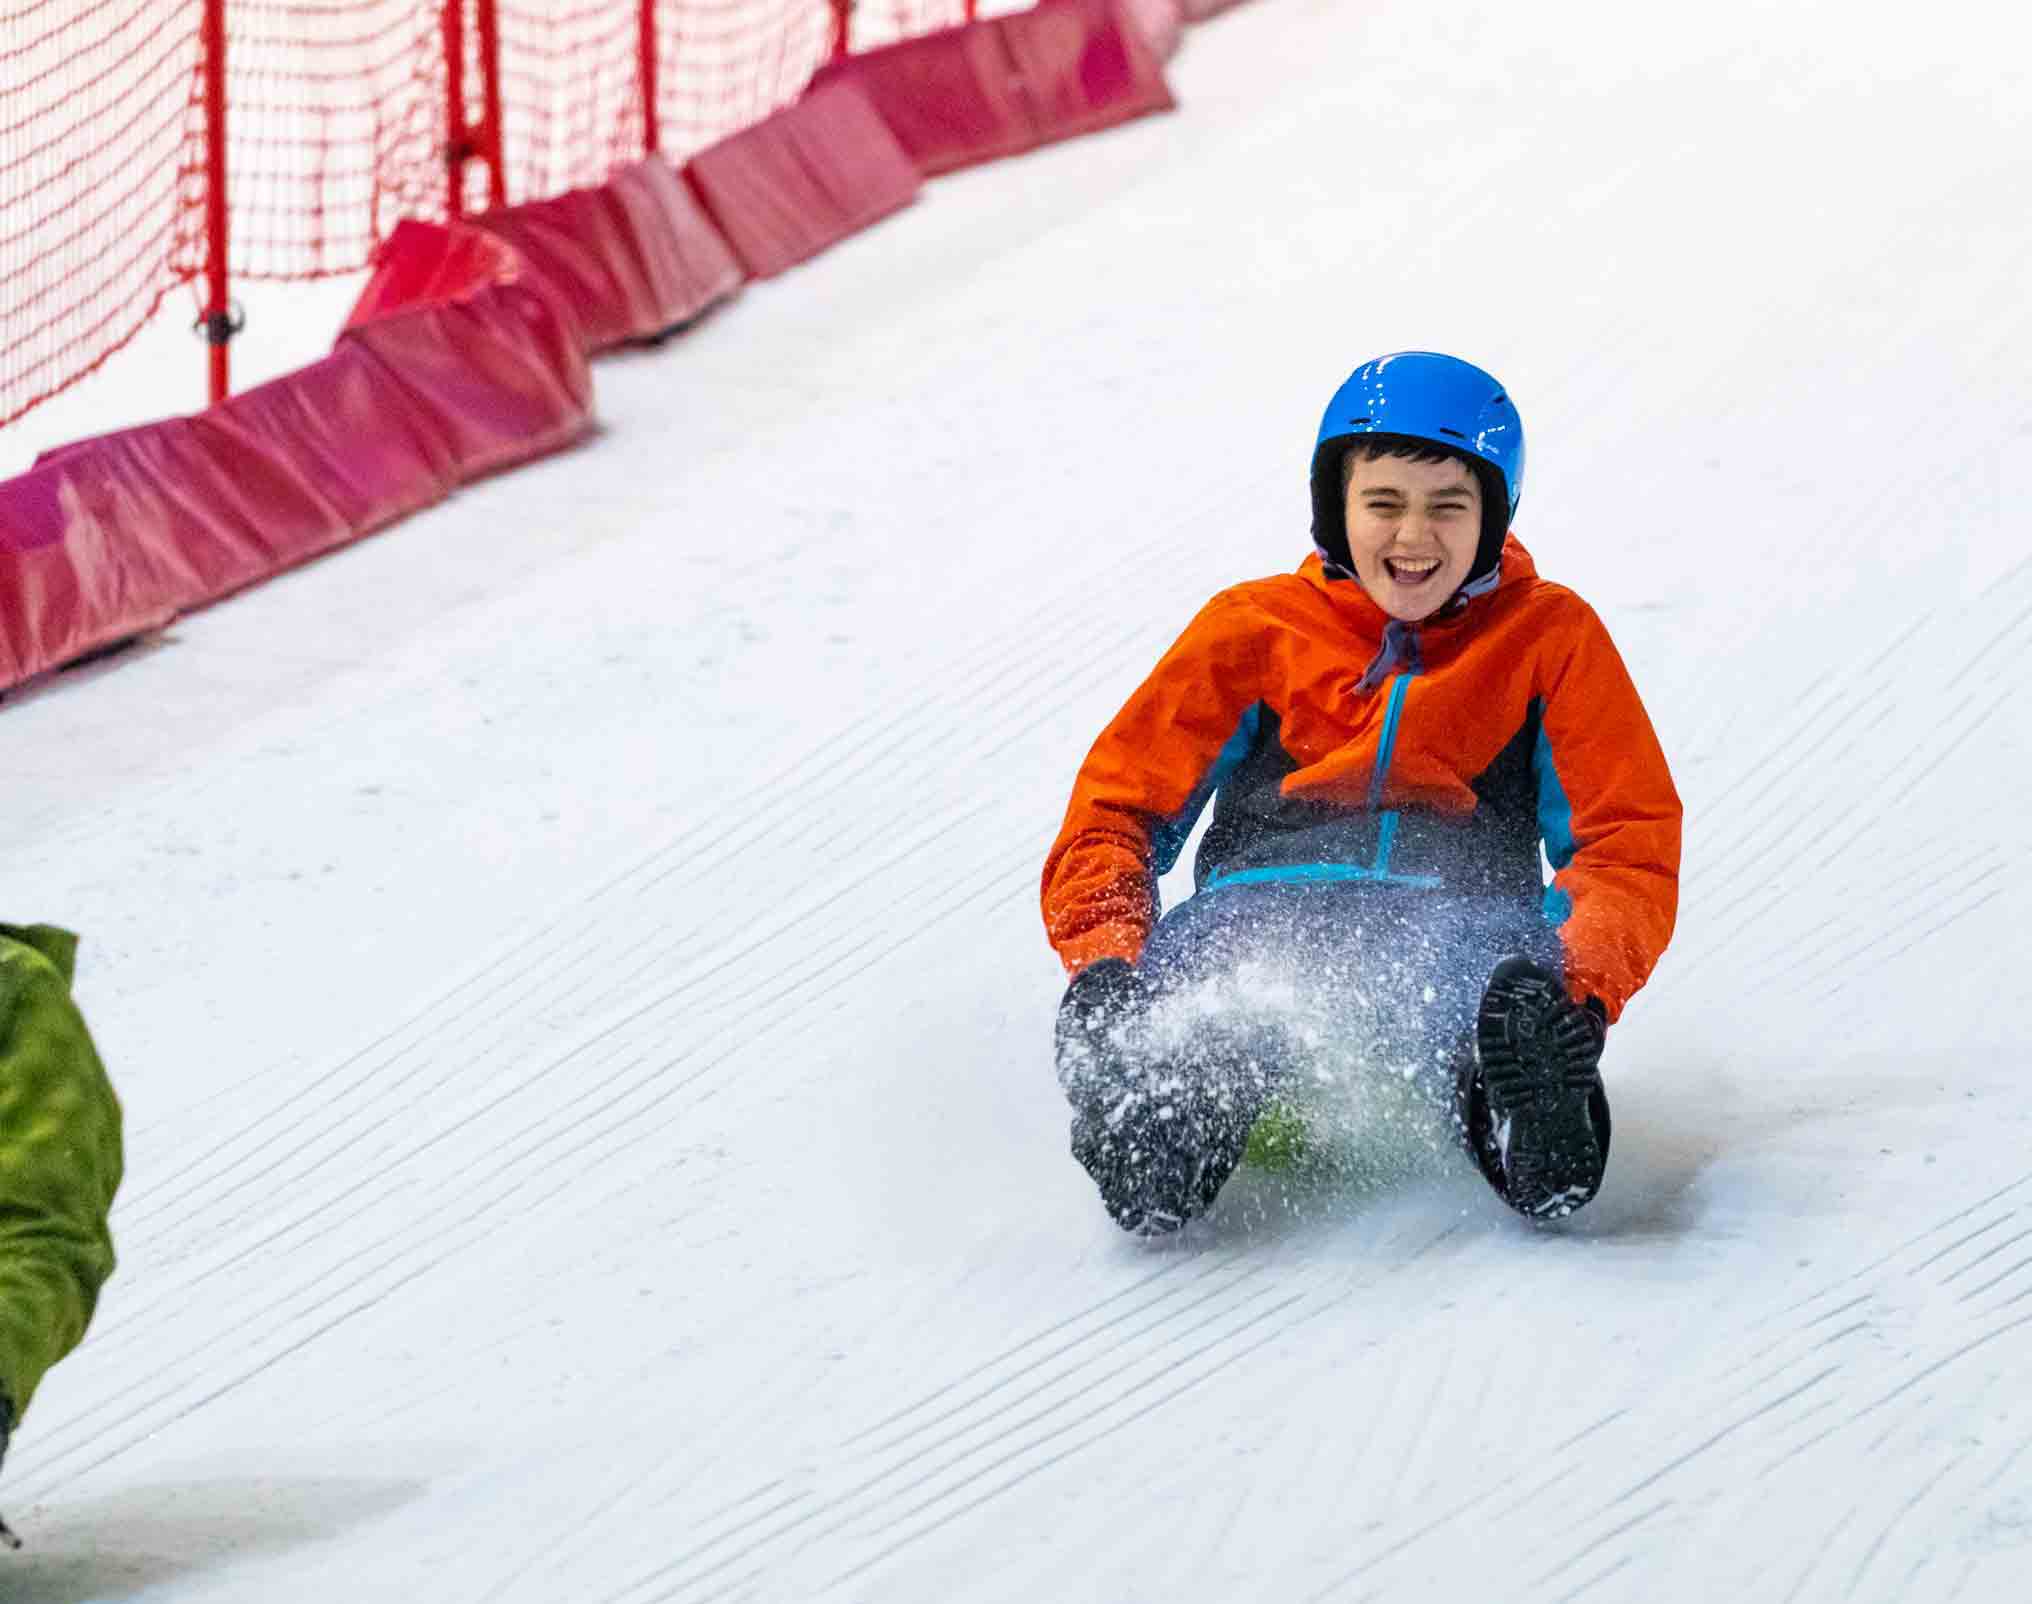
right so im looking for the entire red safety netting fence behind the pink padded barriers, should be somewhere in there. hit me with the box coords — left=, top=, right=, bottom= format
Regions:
left=0, top=0, right=991, bottom=437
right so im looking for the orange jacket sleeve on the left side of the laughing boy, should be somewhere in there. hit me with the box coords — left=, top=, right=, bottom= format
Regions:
left=1042, top=594, right=1260, bottom=974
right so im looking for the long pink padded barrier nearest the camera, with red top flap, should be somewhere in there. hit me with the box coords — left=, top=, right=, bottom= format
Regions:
left=0, top=232, right=591, bottom=689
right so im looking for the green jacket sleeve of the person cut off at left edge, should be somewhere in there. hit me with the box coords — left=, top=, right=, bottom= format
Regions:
left=0, top=925, right=122, bottom=1419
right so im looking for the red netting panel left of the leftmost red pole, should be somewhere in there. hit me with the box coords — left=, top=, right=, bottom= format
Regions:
left=0, top=0, right=203, bottom=423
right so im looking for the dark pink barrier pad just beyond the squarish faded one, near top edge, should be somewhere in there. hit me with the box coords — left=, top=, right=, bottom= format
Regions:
left=817, top=0, right=1177, bottom=175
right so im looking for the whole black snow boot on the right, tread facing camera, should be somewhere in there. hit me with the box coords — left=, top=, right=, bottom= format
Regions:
left=1459, top=958, right=1609, bottom=1220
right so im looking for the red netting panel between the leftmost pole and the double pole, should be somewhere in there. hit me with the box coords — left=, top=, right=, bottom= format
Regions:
left=213, top=0, right=447, bottom=279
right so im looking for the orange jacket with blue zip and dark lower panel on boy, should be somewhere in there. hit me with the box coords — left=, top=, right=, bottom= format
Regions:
left=1042, top=537, right=1680, bottom=1019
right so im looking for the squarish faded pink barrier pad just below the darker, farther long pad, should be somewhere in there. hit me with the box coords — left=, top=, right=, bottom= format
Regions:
left=685, top=83, right=923, bottom=279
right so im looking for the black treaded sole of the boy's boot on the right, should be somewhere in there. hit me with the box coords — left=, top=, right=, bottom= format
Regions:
left=1475, top=962, right=1605, bottom=1220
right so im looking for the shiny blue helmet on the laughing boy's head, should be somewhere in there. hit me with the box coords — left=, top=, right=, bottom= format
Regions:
left=1313, top=352, right=1524, bottom=579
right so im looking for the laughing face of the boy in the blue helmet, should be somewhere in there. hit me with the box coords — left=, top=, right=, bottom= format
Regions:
left=1345, top=457, right=1481, bottom=624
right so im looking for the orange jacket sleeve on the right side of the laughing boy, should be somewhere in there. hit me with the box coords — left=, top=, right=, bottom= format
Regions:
left=1536, top=602, right=1680, bottom=1021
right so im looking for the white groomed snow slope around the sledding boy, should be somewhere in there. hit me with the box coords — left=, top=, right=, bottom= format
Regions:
left=0, top=0, right=2032, bottom=1604
